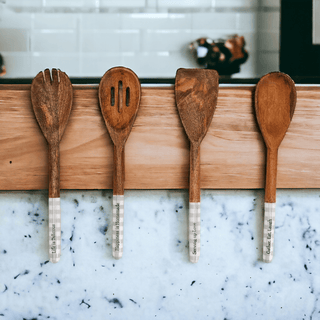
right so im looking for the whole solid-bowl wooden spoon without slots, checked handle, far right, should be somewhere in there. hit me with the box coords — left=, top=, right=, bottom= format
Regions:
left=255, top=72, right=297, bottom=262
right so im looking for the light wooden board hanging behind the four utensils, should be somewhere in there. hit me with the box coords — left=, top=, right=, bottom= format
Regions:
left=0, top=85, right=320, bottom=190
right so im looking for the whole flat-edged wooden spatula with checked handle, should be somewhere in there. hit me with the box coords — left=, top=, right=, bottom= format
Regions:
left=175, top=68, right=219, bottom=263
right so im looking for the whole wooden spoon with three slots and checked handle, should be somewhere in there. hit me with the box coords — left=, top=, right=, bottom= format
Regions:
left=99, top=67, right=141, bottom=259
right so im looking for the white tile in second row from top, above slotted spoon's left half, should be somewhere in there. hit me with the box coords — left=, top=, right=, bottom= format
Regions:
left=81, top=13, right=121, bottom=30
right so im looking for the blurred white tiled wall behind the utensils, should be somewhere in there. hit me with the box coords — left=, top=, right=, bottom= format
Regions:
left=0, top=0, right=280, bottom=78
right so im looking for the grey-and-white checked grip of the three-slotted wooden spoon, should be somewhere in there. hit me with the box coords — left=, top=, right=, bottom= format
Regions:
left=112, top=195, right=124, bottom=259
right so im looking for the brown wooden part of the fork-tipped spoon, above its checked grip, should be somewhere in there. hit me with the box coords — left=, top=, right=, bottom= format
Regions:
left=31, top=69, right=73, bottom=198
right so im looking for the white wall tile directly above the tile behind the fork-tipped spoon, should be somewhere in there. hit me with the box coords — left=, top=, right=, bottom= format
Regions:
left=32, top=30, right=78, bottom=52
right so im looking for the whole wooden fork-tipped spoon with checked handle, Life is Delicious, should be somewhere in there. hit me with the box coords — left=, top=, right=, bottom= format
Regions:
left=31, top=69, right=73, bottom=263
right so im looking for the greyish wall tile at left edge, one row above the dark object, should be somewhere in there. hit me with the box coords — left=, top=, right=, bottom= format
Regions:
left=0, top=29, right=30, bottom=52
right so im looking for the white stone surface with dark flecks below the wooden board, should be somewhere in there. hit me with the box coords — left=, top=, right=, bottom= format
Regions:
left=0, top=190, right=320, bottom=320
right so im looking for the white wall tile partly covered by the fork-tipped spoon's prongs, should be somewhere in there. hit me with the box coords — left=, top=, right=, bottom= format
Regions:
left=32, top=53, right=80, bottom=77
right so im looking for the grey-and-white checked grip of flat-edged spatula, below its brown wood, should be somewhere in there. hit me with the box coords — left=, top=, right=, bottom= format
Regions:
left=189, top=202, right=200, bottom=263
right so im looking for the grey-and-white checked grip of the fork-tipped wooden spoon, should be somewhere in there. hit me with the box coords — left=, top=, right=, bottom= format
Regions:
left=49, top=198, right=61, bottom=263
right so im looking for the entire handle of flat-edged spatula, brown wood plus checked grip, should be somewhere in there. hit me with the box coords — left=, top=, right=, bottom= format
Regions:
left=189, top=143, right=201, bottom=263
